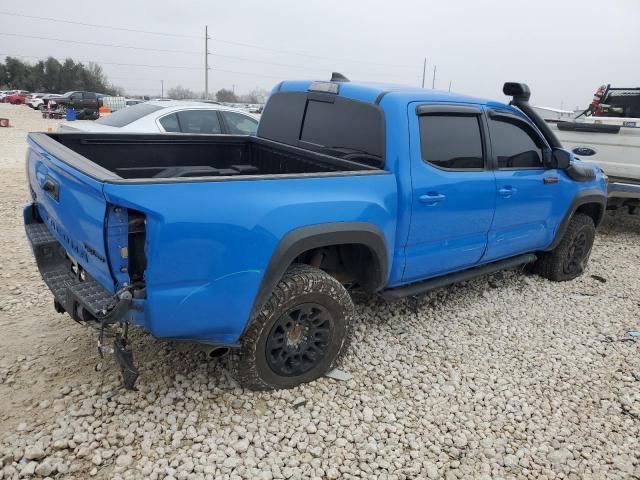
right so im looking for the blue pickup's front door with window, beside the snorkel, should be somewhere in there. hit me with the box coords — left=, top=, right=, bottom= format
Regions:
left=485, top=110, right=561, bottom=261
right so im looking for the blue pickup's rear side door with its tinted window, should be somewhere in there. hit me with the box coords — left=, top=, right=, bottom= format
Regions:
left=403, top=103, right=496, bottom=282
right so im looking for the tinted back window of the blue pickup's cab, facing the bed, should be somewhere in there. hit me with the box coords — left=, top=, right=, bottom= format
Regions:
left=258, top=92, right=385, bottom=168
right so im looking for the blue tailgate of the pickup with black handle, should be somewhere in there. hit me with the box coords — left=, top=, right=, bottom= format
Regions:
left=27, top=134, right=115, bottom=293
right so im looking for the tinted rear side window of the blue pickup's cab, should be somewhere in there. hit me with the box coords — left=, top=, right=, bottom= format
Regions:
left=420, top=115, right=484, bottom=170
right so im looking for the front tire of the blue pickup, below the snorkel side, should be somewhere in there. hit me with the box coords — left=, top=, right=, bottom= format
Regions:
left=533, top=213, right=596, bottom=282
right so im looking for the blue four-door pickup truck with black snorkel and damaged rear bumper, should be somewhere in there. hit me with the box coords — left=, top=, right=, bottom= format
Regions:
left=24, top=75, right=607, bottom=389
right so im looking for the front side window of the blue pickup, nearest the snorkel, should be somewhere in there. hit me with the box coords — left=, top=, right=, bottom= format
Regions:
left=489, top=119, right=543, bottom=168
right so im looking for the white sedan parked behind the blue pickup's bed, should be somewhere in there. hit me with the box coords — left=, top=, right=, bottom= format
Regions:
left=58, top=100, right=258, bottom=135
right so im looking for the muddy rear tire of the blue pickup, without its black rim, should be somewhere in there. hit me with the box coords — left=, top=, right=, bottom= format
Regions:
left=229, top=264, right=354, bottom=390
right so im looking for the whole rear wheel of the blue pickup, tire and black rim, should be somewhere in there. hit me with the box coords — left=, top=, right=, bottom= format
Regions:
left=230, top=265, right=354, bottom=390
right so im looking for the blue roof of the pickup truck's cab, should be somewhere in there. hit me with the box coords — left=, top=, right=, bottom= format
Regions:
left=273, top=80, right=511, bottom=109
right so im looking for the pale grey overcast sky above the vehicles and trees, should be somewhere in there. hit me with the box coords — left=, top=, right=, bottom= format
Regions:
left=0, top=0, right=640, bottom=108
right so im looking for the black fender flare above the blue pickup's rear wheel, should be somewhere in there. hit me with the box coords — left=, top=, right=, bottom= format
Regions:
left=250, top=222, right=389, bottom=320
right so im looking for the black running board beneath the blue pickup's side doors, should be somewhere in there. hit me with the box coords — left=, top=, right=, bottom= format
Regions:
left=382, top=253, right=537, bottom=300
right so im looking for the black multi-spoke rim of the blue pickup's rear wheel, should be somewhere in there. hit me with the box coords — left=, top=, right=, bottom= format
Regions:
left=266, top=303, right=334, bottom=377
